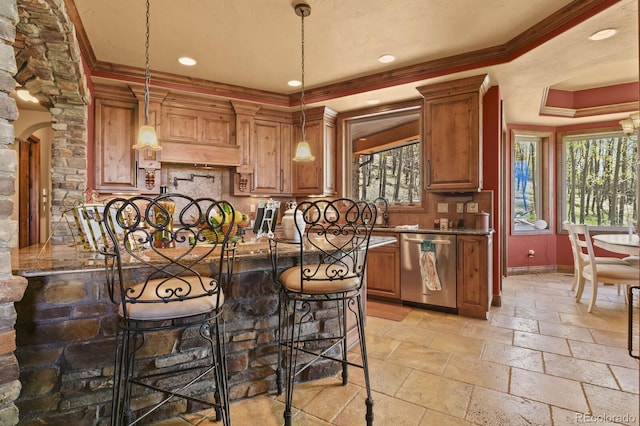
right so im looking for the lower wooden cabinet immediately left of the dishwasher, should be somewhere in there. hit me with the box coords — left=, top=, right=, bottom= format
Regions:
left=367, top=234, right=400, bottom=300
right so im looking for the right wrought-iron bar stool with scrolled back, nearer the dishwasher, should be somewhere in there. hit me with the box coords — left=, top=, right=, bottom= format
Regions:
left=270, top=198, right=377, bottom=426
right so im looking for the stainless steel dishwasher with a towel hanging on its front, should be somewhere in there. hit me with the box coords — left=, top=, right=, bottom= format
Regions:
left=400, top=233, right=457, bottom=311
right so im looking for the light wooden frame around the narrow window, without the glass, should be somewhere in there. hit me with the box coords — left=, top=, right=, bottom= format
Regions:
left=509, top=129, right=554, bottom=235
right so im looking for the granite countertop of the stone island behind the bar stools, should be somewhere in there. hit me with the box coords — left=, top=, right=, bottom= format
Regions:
left=11, top=235, right=396, bottom=277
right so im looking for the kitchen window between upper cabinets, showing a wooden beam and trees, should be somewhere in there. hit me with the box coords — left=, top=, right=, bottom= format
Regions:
left=342, top=104, right=424, bottom=209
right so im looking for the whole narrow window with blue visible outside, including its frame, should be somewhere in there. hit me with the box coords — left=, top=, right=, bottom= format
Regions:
left=511, top=131, right=551, bottom=233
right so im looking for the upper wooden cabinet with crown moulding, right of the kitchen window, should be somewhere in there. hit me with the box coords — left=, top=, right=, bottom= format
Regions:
left=418, top=75, right=489, bottom=192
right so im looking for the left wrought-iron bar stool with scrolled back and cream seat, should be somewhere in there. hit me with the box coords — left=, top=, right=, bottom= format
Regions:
left=101, top=193, right=235, bottom=426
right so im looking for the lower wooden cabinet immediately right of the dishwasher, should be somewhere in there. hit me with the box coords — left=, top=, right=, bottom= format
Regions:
left=457, top=234, right=493, bottom=319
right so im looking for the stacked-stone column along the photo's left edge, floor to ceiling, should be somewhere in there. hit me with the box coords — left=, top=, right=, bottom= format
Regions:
left=0, top=0, right=27, bottom=425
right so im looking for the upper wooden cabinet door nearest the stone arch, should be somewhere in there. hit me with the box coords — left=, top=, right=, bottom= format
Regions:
left=95, top=97, right=138, bottom=191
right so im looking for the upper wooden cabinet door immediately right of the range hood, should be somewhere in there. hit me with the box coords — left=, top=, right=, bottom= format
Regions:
left=251, top=120, right=292, bottom=195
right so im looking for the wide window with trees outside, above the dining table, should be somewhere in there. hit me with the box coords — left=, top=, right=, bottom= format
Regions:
left=559, top=131, right=638, bottom=227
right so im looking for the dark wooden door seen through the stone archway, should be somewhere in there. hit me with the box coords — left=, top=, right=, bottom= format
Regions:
left=18, top=136, right=40, bottom=248
